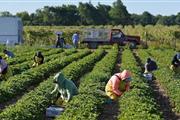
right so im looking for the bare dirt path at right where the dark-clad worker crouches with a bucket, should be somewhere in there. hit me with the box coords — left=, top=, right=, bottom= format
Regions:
left=133, top=51, right=180, bottom=120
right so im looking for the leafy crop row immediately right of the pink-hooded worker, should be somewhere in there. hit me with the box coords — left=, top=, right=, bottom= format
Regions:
left=118, top=50, right=162, bottom=120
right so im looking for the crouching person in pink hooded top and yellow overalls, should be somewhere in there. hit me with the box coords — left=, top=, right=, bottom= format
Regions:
left=105, top=70, right=131, bottom=100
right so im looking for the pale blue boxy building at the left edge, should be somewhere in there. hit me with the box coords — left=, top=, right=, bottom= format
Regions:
left=0, top=17, right=23, bottom=45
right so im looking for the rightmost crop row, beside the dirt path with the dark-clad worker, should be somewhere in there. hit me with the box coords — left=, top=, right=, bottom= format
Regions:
left=138, top=49, right=180, bottom=113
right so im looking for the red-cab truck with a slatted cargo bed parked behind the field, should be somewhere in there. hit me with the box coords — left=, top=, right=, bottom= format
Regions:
left=81, top=29, right=140, bottom=48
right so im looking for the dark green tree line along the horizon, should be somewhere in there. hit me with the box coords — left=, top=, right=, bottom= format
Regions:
left=0, top=0, right=180, bottom=26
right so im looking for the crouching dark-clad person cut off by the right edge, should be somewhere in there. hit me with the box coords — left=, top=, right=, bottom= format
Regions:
left=170, top=53, right=180, bottom=72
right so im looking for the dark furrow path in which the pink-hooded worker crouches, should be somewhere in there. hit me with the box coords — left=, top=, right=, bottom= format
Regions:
left=98, top=47, right=122, bottom=120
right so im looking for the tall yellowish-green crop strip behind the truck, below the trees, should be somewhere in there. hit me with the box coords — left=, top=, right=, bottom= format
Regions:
left=23, top=25, right=180, bottom=49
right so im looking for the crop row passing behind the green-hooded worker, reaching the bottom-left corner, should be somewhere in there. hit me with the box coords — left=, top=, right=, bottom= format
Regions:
left=0, top=50, right=104, bottom=120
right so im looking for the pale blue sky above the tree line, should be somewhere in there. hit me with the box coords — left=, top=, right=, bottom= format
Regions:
left=0, top=0, right=180, bottom=16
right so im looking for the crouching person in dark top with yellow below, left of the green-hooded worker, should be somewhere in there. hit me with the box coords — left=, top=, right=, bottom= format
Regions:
left=32, top=51, right=44, bottom=67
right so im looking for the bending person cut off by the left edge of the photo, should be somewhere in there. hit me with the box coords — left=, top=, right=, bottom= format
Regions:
left=0, top=56, right=11, bottom=80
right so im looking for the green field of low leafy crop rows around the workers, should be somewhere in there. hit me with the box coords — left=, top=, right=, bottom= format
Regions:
left=0, top=45, right=180, bottom=120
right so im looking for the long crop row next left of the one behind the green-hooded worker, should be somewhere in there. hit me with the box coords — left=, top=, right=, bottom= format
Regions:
left=0, top=50, right=90, bottom=103
